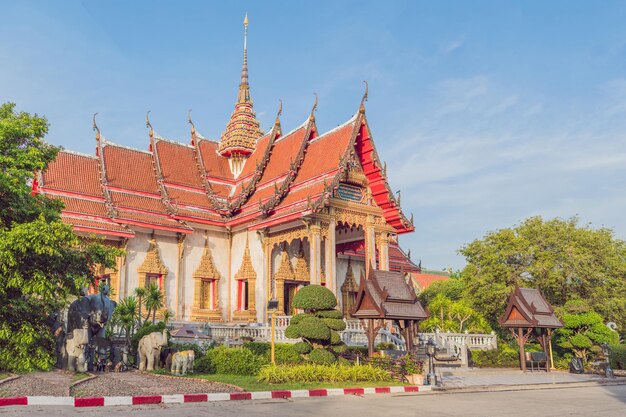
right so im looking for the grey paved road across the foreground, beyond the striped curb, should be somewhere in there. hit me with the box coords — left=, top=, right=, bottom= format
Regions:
left=0, top=385, right=626, bottom=417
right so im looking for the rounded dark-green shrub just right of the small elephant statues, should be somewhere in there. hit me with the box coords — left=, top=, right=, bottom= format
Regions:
left=206, top=346, right=267, bottom=375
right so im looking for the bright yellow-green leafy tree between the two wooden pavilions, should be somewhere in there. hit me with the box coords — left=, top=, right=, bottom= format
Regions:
left=420, top=294, right=491, bottom=333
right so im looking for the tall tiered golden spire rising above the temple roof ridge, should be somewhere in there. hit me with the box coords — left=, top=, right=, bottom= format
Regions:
left=219, top=14, right=263, bottom=163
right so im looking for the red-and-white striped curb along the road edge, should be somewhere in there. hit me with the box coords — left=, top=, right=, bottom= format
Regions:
left=0, top=386, right=431, bottom=407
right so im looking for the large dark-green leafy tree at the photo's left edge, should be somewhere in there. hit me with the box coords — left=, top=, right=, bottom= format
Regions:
left=0, top=103, right=119, bottom=371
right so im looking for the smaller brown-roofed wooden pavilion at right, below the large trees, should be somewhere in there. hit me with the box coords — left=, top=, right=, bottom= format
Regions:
left=498, top=287, right=563, bottom=372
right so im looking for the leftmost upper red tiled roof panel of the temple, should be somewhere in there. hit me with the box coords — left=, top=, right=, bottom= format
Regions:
left=43, top=151, right=102, bottom=197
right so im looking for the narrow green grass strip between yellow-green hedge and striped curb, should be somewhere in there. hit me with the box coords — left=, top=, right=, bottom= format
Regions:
left=192, top=374, right=404, bottom=391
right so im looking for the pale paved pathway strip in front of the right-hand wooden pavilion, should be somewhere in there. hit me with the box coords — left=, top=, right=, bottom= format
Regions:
left=437, top=369, right=608, bottom=388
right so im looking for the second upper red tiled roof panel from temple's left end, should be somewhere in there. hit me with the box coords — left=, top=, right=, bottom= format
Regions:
left=102, top=144, right=159, bottom=194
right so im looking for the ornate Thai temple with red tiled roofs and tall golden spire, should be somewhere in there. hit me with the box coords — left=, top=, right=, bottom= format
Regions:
left=33, top=18, right=420, bottom=323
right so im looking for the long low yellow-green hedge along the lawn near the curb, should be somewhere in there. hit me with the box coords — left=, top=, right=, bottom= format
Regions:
left=258, top=364, right=391, bottom=384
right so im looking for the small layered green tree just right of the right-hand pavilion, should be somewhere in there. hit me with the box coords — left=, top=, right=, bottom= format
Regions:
left=556, top=300, right=619, bottom=362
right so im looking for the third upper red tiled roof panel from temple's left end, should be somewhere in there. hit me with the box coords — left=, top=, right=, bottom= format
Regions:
left=156, top=140, right=202, bottom=188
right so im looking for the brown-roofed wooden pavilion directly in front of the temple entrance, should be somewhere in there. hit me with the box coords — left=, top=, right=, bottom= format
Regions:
left=351, top=268, right=428, bottom=356
